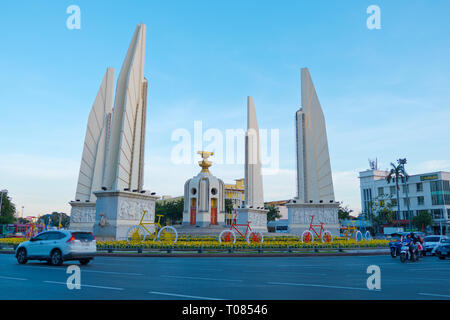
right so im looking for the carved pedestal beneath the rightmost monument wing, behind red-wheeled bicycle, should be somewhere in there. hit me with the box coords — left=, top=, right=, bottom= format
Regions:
left=286, top=200, right=340, bottom=236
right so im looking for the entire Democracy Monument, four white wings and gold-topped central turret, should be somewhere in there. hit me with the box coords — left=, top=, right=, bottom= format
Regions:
left=69, top=24, right=339, bottom=240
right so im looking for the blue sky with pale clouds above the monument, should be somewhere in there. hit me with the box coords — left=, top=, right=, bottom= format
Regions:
left=0, top=0, right=450, bottom=215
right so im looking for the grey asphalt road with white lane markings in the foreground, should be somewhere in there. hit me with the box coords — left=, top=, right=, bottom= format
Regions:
left=0, top=254, right=450, bottom=300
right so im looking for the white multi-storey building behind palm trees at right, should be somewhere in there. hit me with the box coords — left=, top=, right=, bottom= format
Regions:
left=359, top=170, right=450, bottom=234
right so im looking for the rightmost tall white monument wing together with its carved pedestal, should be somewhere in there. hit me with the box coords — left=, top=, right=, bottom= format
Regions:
left=286, top=68, right=339, bottom=235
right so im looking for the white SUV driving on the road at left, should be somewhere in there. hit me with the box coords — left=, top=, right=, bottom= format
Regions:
left=16, top=230, right=97, bottom=265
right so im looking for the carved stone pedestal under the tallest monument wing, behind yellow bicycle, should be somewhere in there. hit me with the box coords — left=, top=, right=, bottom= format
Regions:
left=94, top=191, right=158, bottom=240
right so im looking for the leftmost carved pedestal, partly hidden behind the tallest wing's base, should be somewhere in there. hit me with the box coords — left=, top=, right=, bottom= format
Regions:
left=69, top=201, right=95, bottom=232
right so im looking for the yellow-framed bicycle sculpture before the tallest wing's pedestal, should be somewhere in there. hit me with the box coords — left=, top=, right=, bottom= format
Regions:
left=127, top=210, right=178, bottom=243
